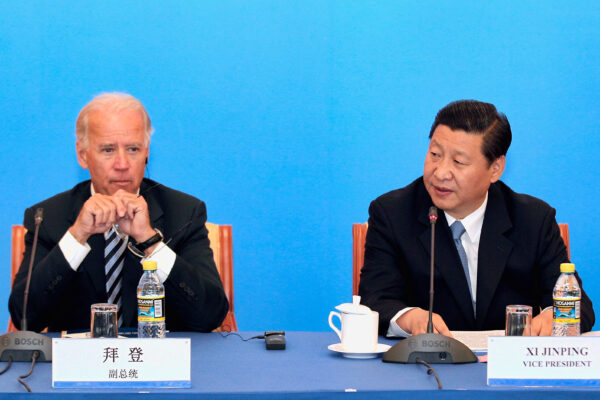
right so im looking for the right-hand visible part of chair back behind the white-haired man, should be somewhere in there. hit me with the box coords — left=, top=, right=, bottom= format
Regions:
left=206, top=222, right=237, bottom=332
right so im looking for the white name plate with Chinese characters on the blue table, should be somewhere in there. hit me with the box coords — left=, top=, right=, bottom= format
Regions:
left=52, top=338, right=191, bottom=389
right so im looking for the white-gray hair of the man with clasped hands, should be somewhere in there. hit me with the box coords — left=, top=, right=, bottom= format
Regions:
left=75, top=92, right=154, bottom=149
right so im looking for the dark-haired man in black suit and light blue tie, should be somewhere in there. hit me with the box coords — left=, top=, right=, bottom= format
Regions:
left=359, top=100, right=594, bottom=336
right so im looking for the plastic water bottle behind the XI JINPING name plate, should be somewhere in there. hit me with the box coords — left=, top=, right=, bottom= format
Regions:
left=552, top=263, right=581, bottom=336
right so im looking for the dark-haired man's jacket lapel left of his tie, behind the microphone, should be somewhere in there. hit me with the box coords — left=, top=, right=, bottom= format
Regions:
left=417, top=186, right=475, bottom=326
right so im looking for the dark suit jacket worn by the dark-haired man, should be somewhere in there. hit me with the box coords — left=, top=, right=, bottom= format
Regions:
left=359, top=178, right=594, bottom=333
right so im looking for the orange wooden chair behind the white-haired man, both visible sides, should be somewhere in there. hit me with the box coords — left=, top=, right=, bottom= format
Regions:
left=7, top=222, right=237, bottom=332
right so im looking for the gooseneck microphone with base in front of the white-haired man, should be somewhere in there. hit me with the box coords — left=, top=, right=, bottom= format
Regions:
left=0, top=208, right=52, bottom=362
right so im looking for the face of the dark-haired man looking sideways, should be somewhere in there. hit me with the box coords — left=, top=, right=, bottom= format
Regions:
left=423, top=125, right=506, bottom=219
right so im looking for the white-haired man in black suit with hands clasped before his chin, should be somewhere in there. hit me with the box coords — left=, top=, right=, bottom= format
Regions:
left=9, top=93, right=229, bottom=332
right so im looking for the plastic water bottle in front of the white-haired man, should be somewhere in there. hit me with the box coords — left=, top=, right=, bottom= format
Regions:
left=137, top=261, right=166, bottom=338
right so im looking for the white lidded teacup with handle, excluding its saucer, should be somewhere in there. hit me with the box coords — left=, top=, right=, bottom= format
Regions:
left=329, top=296, right=379, bottom=353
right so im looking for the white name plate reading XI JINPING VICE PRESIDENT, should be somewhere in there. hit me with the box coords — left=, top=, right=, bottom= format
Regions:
left=487, top=336, right=600, bottom=386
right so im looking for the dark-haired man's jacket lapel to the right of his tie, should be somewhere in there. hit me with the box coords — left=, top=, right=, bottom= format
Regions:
left=476, top=185, right=513, bottom=329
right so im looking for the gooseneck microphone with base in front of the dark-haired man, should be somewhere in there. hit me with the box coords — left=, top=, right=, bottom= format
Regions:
left=383, top=206, right=477, bottom=364
